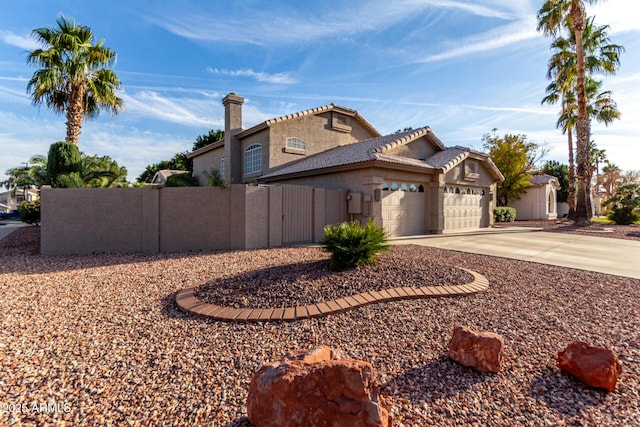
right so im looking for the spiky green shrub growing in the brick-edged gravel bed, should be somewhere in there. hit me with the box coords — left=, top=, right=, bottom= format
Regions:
left=320, top=219, right=389, bottom=270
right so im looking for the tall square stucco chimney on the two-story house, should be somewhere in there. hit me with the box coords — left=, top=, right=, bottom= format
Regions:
left=222, top=92, right=244, bottom=184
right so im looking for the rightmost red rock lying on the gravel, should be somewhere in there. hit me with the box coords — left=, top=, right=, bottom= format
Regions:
left=558, top=341, right=622, bottom=392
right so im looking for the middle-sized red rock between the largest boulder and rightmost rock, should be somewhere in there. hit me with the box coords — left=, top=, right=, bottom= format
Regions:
left=449, top=326, right=504, bottom=373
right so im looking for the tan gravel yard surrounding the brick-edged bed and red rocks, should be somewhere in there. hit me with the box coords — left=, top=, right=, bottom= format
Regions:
left=0, top=227, right=640, bottom=426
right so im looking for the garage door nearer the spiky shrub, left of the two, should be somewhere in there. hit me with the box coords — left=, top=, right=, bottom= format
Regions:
left=382, top=184, right=426, bottom=236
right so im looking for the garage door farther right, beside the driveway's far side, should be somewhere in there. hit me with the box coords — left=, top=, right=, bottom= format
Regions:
left=444, top=187, right=488, bottom=231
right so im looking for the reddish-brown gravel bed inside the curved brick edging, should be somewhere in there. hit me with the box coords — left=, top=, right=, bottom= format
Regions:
left=195, top=246, right=473, bottom=308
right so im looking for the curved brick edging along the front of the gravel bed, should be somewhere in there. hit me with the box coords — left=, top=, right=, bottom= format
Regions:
left=176, top=267, right=489, bottom=322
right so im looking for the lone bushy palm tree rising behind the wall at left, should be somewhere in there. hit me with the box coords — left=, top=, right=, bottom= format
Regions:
left=27, top=15, right=123, bottom=145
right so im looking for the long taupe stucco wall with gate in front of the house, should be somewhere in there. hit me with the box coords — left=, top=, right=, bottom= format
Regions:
left=41, top=185, right=348, bottom=255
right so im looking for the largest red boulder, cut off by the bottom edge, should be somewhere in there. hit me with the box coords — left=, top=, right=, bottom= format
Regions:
left=247, top=346, right=392, bottom=427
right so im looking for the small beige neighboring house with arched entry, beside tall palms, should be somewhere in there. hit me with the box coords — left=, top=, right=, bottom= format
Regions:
left=509, top=174, right=560, bottom=220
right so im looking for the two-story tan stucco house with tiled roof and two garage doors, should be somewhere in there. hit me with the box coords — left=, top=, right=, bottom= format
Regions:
left=188, top=93, right=504, bottom=236
